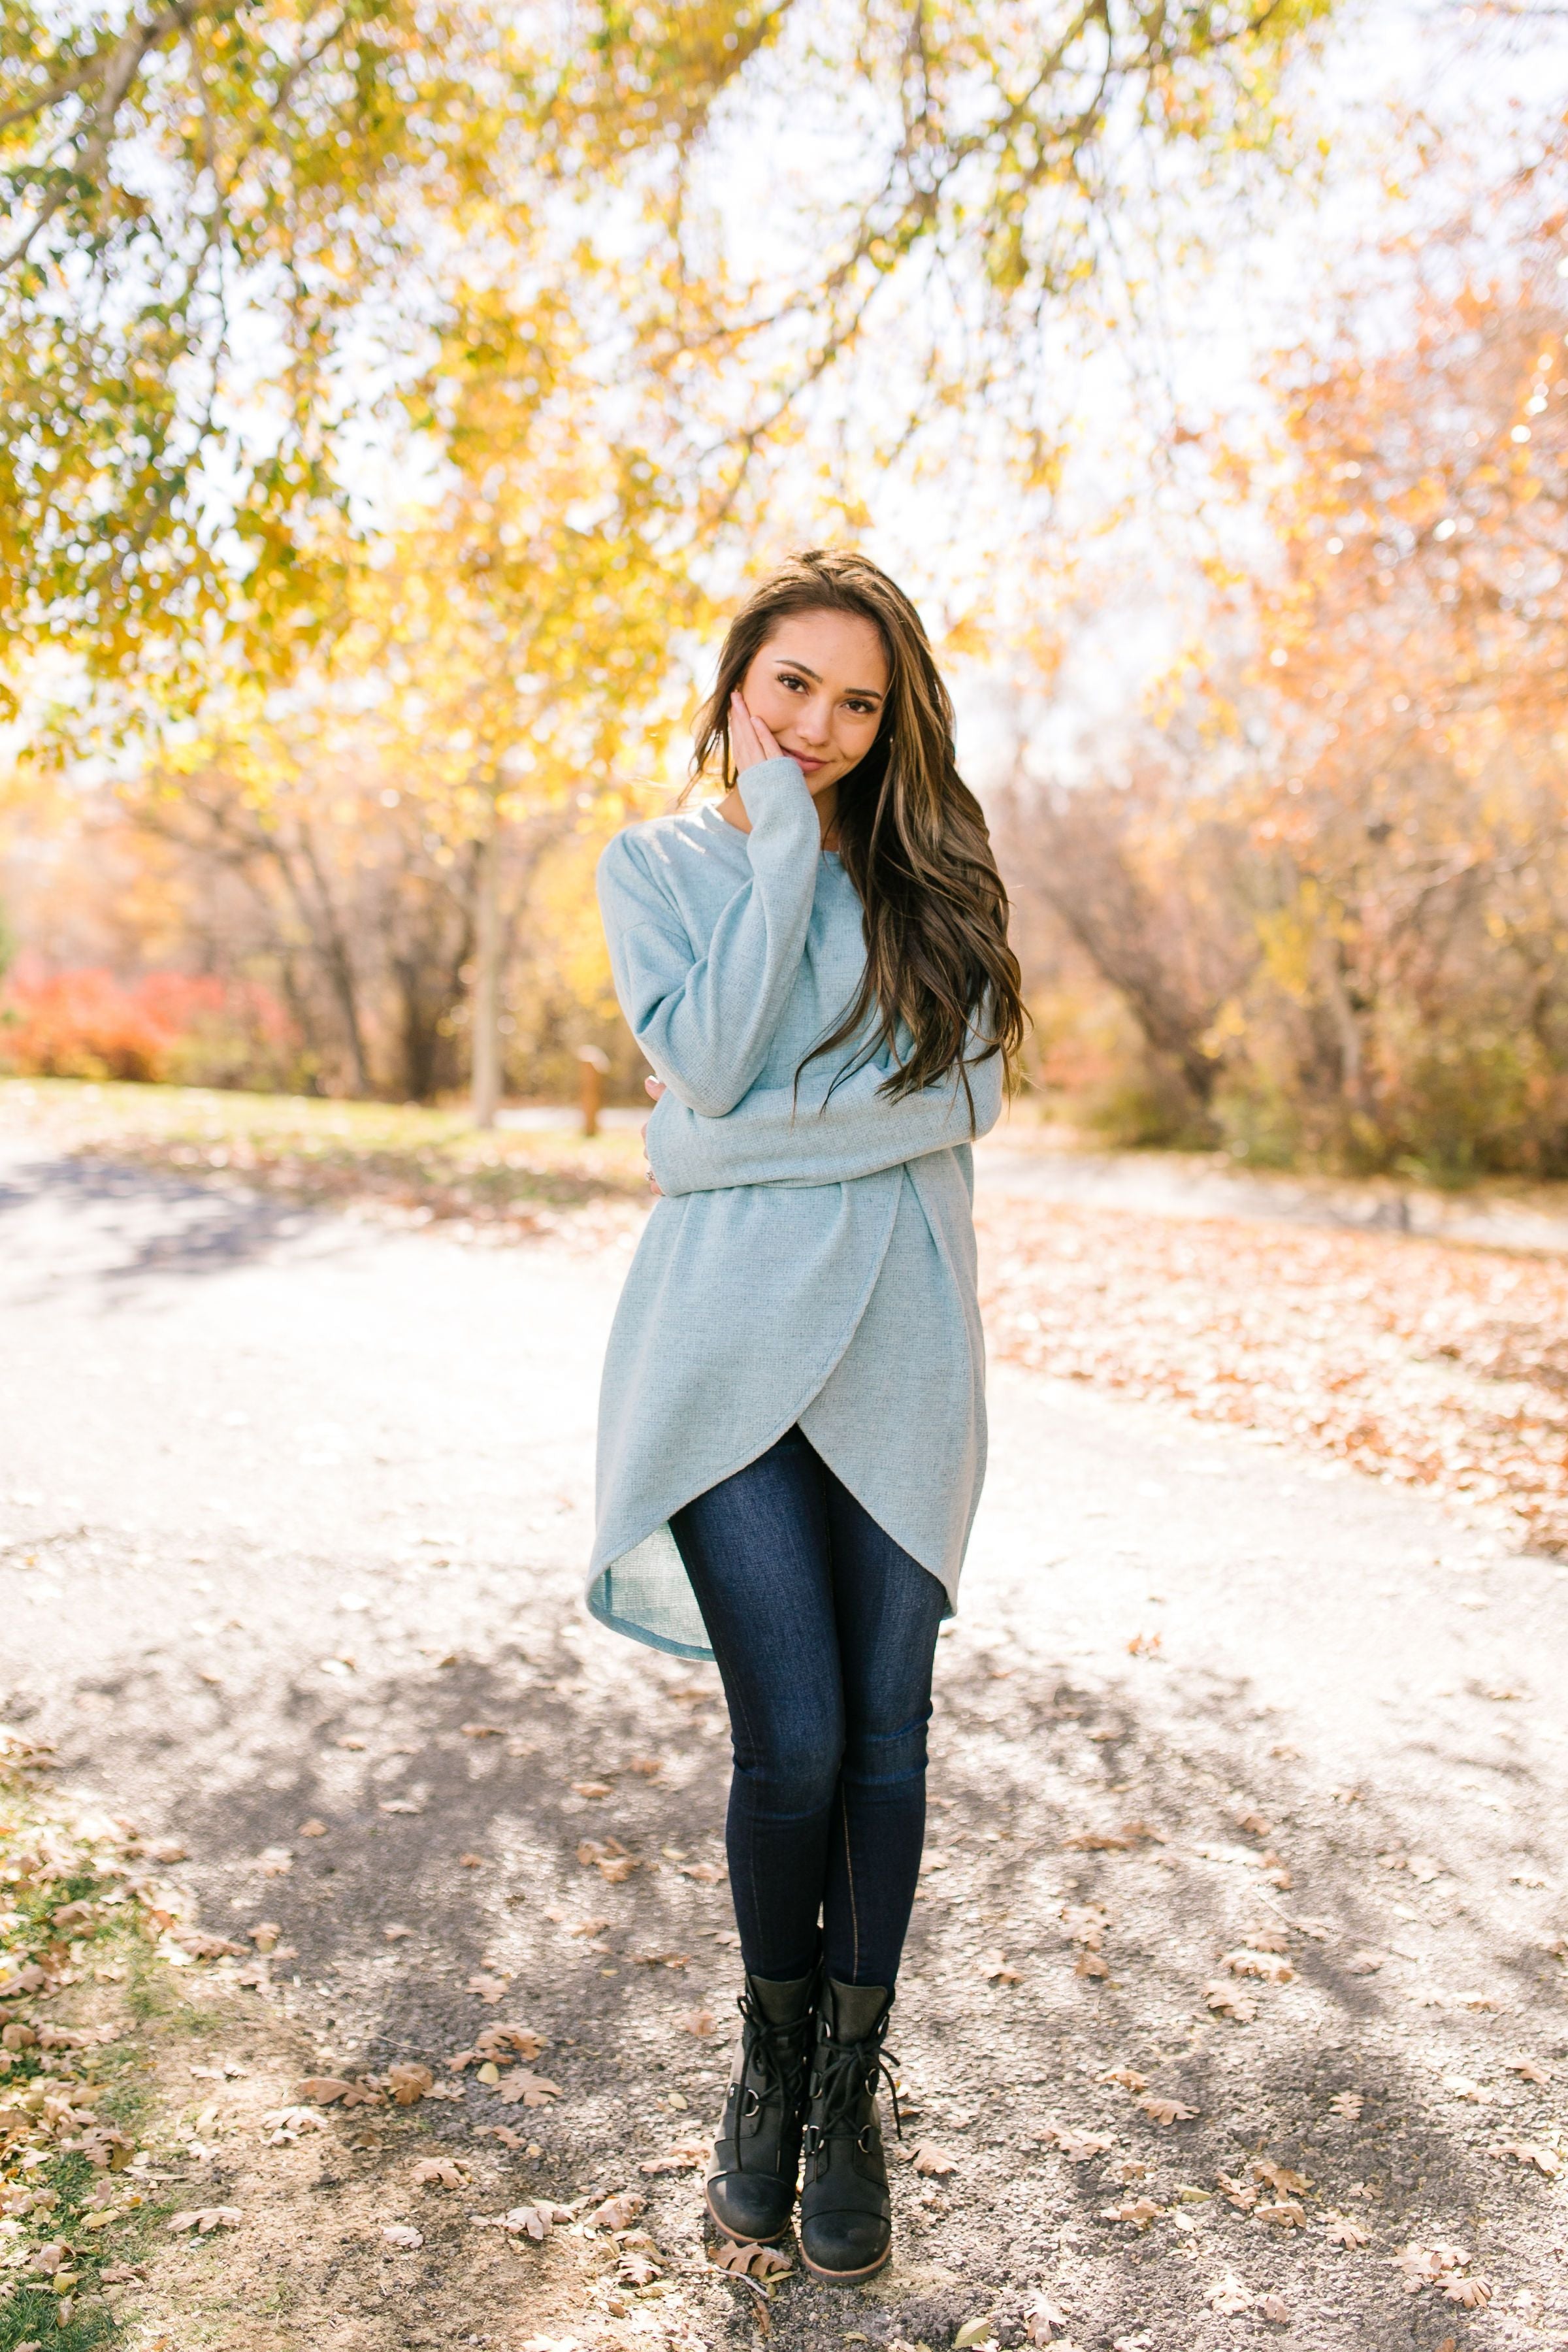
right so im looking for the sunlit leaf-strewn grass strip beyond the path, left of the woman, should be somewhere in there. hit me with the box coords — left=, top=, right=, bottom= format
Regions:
left=0, top=1079, right=644, bottom=1223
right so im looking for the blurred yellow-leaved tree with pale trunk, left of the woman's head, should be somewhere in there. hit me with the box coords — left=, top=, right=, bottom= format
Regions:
left=125, top=294, right=703, bottom=1100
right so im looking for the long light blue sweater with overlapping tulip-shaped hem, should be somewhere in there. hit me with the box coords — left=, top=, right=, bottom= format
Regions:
left=588, top=760, right=1002, bottom=1658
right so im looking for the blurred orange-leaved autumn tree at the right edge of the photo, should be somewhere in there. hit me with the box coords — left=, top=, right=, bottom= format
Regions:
left=1004, top=243, right=1568, bottom=1181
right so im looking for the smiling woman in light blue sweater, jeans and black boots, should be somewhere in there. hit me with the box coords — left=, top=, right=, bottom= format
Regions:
left=588, top=550, right=1022, bottom=2281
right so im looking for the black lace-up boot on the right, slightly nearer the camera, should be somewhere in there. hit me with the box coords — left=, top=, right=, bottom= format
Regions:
left=799, top=1976, right=898, bottom=2284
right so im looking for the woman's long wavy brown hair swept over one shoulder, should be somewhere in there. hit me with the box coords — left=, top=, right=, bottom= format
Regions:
left=691, top=548, right=1025, bottom=1120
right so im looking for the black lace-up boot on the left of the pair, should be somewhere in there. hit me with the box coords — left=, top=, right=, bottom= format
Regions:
left=708, top=1968, right=818, bottom=2246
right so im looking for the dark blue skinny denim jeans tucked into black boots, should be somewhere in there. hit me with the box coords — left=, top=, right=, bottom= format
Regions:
left=670, top=1430, right=947, bottom=1987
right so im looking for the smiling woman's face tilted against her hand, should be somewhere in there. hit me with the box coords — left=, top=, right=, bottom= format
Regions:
left=740, top=612, right=889, bottom=800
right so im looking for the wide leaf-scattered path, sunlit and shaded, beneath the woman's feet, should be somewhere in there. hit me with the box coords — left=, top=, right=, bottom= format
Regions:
left=0, top=1138, right=1568, bottom=2352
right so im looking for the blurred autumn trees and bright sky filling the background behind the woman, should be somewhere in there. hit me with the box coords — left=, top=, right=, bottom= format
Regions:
left=0, top=0, right=1568, bottom=1185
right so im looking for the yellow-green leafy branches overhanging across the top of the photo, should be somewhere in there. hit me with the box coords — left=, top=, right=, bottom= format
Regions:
left=0, top=0, right=1328, bottom=734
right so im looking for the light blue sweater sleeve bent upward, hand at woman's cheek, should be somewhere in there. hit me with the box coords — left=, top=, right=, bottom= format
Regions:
left=600, top=760, right=823, bottom=1120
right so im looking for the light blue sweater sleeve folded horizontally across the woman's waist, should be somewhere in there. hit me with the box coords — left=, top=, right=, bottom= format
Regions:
left=647, top=1021, right=1004, bottom=1197
